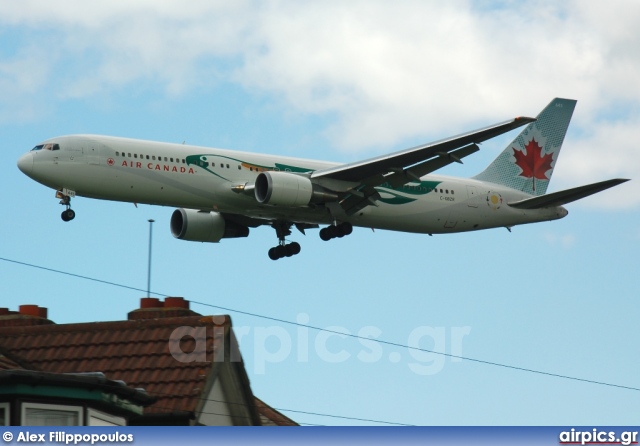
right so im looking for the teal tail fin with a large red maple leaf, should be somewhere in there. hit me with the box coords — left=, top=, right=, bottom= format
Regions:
left=474, top=98, right=577, bottom=195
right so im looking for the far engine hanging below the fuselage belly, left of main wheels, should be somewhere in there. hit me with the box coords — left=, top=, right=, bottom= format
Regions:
left=171, top=209, right=249, bottom=243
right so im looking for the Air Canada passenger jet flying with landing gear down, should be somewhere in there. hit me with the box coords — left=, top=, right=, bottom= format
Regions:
left=18, top=98, right=628, bottom=260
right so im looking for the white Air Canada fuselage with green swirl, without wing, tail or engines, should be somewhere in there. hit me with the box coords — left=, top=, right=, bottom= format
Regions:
left=18, top=135, right=567, bottom=234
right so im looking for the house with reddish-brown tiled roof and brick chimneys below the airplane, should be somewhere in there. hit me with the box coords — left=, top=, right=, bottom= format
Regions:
left=0, top=297, right=297, bottom=426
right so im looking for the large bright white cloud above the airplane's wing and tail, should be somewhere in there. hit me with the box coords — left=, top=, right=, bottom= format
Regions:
left=234, top=1, right=632, bottom=149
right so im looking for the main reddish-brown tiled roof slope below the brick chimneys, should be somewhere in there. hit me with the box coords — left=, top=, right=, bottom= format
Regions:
left=0, top=315, right=245, bottom=415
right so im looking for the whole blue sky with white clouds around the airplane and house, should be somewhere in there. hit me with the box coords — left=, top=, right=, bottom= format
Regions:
left=0, top=0, right=640, bottom=426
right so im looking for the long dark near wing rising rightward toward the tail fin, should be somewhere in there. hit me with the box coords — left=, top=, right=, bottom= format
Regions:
left=311, top=117, right=535, bottom=215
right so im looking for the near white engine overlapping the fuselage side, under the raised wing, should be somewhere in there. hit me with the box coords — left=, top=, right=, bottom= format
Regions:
left=255, top=172, right=313, bottom=206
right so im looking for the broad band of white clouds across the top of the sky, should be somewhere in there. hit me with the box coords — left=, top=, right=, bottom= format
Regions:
left=0, top=0, right=640, bottom=208
